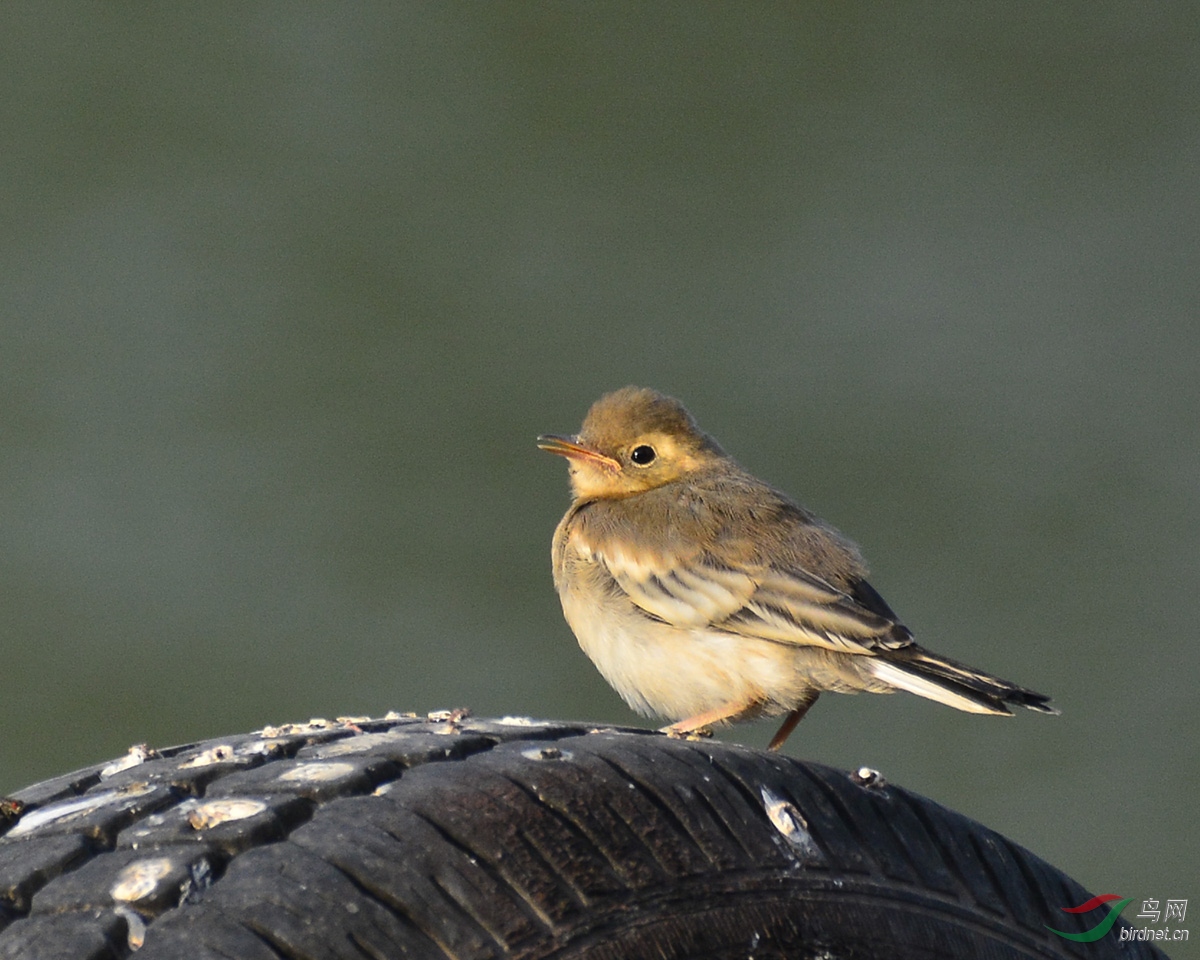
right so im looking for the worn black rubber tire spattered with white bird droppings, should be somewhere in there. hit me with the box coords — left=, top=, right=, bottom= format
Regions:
left=0, top=714, right=1163, bottom=960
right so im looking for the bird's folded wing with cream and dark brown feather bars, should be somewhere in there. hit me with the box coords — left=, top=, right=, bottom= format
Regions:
left=593, top=550, right=912, bottom=654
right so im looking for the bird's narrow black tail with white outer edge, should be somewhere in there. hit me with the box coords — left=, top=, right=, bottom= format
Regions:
left=862, top=643, right=1058, bottom=716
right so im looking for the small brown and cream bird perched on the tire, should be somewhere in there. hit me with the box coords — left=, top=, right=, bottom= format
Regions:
left=538, top=386, right=1058, bottom=750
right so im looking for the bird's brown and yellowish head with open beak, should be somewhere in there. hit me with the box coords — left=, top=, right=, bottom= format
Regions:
left=538, top=386, right=725, bottom=499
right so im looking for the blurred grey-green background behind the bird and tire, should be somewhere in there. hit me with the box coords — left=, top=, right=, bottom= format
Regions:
left=0, top=2, right=1200, bottom=916
